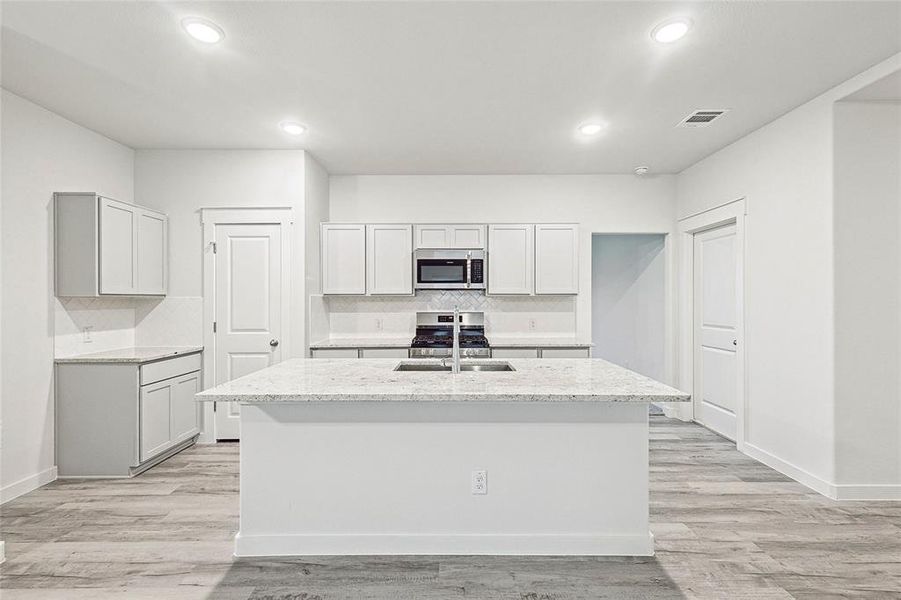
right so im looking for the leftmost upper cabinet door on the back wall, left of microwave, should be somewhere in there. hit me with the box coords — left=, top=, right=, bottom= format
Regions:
left=320, top=223, right=366, bottom=295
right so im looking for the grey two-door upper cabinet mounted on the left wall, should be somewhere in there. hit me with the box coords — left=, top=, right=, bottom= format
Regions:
left=54, top=193, right=168, bottom=296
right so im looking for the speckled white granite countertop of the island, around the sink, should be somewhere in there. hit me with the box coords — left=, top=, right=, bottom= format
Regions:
left=197, top=358, right=690, bottom=403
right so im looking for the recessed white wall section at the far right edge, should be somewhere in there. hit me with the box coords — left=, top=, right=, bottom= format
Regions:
left=834, top=102, right=901, bottom=490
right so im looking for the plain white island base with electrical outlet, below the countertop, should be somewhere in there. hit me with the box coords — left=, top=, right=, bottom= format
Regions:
left=235, top=400, right=654, bottom=556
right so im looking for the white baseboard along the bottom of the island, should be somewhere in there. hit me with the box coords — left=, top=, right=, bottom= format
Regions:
left=235, top=532, right=654, bottom=556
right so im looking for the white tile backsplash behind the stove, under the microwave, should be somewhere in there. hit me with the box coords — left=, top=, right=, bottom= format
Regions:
left=320, top=290, right=576, bottom=341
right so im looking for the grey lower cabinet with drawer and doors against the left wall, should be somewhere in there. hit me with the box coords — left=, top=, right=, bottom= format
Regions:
left=56, top=353, right=201, bottom=477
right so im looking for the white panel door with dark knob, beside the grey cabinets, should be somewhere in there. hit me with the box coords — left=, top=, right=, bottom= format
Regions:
left=215, top=224, right=287, bottom=440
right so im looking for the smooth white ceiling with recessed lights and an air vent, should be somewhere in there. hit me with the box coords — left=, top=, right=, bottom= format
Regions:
left=2, top=1, right=901, bottom=173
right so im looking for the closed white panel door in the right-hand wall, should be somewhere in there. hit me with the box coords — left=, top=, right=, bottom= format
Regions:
left=693, top=224, right=740, bottom=440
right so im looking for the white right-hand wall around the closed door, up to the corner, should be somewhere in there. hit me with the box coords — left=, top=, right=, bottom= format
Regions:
left=677, top=55, right=901, bottom=493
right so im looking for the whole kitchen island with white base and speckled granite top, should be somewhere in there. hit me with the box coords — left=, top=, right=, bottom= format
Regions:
left=197, top=359, right=689, bottom=556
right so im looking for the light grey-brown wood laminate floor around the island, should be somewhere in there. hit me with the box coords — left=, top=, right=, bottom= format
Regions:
left=0, top=417, right=901, bottom=600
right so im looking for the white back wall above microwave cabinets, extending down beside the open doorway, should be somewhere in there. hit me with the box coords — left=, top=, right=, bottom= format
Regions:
left=329, top=175, right=675, bottom=340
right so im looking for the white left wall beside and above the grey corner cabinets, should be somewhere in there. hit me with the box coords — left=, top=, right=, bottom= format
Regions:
left=0, top=90, right=134, bottom=500
